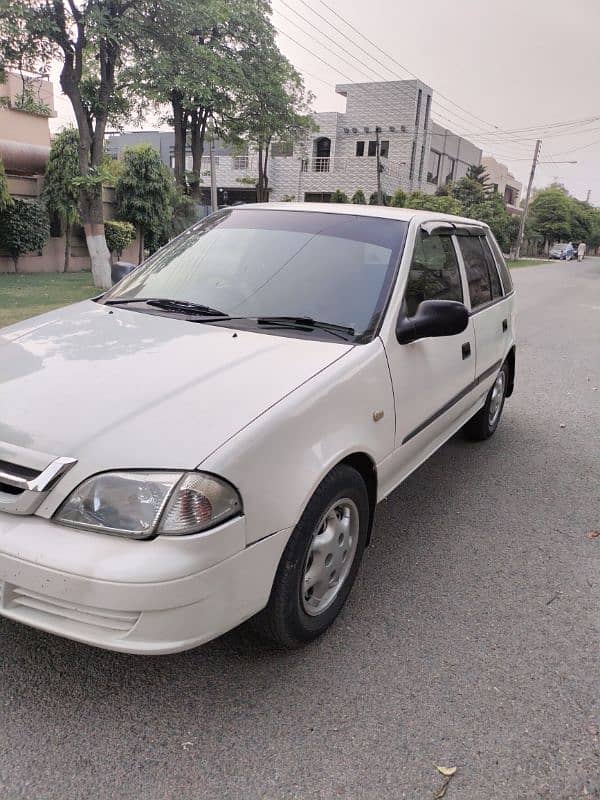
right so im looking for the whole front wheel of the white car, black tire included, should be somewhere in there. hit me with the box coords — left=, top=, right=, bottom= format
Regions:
left=253, top=464, right=370, bottom=649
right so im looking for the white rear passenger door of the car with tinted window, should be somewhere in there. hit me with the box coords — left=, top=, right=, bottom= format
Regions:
left=456, top=229, right=511, bottom=384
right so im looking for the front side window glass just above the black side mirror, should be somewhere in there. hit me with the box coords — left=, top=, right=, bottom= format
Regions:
left=404, top=231, right=463, bottom=317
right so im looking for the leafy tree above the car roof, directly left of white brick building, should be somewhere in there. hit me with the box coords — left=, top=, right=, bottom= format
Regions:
left=232, top=44, right=315, bottom=203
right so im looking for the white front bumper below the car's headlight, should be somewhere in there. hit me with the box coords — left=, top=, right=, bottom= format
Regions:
left=0, top=514, right=290, bottom=655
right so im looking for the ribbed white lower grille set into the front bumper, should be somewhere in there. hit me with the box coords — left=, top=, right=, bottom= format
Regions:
left=3, top=586, right=141, bottom=633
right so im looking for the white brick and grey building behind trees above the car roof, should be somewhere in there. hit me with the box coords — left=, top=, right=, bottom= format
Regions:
left=107, top=80, right=481, bottom=205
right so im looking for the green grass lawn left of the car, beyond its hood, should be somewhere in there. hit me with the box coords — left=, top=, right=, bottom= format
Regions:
left=0, top=272, right=100, bottom=328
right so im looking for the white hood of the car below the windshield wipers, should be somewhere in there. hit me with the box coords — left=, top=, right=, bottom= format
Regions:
left=0, top=301, right=352, bottom=473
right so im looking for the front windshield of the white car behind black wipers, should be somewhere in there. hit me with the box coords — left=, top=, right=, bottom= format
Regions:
left=104, top=207, right=407, bottom=338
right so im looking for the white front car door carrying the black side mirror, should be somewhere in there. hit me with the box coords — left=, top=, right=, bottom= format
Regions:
left=382, top=226, right=475, bottom=480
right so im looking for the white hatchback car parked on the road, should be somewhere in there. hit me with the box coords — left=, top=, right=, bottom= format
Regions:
left=0, top=203, right=515, bottom=654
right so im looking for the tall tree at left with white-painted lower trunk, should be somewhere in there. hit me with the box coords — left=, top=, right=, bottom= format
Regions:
left=0, top=0, right=170, bottom=289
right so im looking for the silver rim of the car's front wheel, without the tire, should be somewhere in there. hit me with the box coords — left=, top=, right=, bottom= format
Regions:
left=300, top=497, right=360, bottom=617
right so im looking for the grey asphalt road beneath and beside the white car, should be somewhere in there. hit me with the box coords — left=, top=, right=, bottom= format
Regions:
left=0, top=259, right=600, bottom=800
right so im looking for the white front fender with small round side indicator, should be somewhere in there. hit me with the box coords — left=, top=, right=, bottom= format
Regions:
left=199, top=339, right=395, bottom=543
